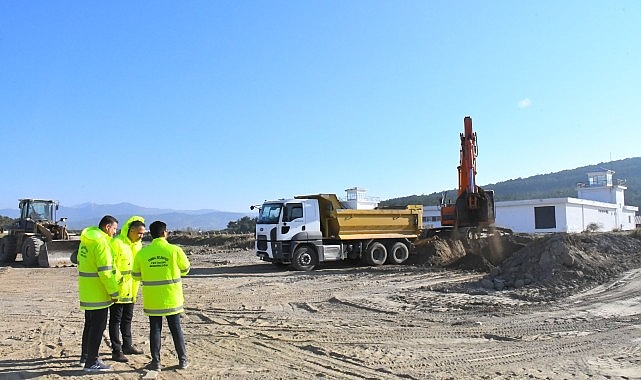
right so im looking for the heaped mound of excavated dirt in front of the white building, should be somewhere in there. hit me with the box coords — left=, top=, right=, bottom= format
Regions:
left=409, top=229, right=641, bottom=300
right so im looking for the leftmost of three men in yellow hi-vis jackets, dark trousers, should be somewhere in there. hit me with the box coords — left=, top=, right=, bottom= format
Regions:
left=78, top=215, right=120, bottom=372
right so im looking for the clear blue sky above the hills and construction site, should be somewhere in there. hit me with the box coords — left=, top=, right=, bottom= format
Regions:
left=0, top=0, right=641, bottom=212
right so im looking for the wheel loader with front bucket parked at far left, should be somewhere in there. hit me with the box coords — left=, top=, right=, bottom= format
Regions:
left=0, top=199, right=80, bottom=268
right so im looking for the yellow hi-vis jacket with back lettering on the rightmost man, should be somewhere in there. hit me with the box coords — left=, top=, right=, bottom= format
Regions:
left=132, top=238, right=190, bottom=316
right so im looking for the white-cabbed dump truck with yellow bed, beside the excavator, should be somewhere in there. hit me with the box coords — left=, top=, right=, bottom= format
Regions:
left=252, top=194, right=423, bottom=271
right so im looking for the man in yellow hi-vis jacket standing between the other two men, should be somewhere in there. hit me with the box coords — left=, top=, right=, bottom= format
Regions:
left=109, top=216, right=145, bottom=362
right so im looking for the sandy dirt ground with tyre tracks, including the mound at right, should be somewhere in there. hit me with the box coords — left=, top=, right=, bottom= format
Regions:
left=0, top=233, right=641, bottom=379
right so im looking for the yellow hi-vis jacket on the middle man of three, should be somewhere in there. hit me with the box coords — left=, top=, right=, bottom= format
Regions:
left=111, top=216, right=145, bottom=303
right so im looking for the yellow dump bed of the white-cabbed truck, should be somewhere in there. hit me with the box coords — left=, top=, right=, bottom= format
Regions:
left=296, top=194, right=423, bottom=240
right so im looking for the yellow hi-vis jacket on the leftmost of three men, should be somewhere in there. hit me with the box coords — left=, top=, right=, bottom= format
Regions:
left=78, top=227, right=118, bottom=310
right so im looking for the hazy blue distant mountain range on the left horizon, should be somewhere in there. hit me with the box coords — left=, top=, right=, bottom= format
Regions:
left=0, top=202, right=255, bottom=231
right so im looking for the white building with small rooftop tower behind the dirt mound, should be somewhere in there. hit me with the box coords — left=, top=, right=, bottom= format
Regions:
left=423, top=170, right=639, bottom=233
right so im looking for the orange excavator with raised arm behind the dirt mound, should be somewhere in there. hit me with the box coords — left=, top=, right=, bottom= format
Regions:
left=430, top=116, right=495, bottom=236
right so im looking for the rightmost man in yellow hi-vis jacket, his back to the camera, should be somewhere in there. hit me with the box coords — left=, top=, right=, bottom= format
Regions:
left=132, top=221, right=190, bottom=371
